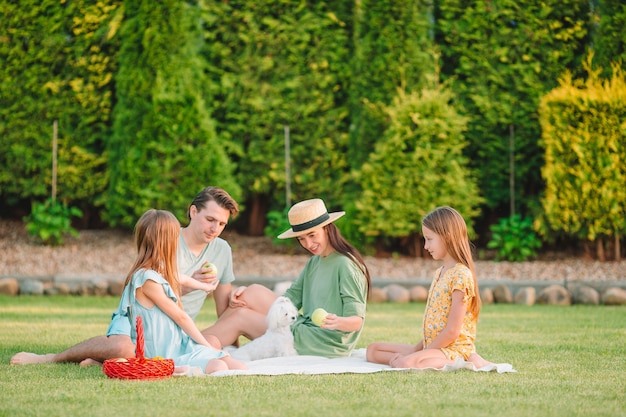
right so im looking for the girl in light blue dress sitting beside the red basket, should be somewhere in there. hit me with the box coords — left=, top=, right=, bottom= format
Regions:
left=120, top=209, right=247, bottom=374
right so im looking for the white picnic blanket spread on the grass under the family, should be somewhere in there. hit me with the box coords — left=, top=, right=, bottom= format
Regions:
left=174, top=349, right=517, bottom=377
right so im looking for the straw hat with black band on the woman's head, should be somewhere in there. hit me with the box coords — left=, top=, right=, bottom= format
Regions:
left=278, top=198, right=346, bottom=239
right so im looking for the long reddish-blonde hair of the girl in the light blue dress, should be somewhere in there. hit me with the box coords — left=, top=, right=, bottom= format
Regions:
left=125, top=209, right=182, bottom=308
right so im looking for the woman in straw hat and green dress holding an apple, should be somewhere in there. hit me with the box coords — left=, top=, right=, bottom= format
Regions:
left=203, top=198, right=371, bottom=357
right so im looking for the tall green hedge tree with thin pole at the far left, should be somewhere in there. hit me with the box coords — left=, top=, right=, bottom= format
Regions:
left=0, top=1, right=121, bottom=216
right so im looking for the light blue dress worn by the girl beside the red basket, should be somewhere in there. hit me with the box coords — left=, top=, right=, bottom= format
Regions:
left=124, top=269, right=228, bottom=371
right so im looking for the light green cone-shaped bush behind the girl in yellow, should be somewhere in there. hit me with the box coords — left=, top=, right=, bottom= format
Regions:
left=355, top=87, right=482, bottom=254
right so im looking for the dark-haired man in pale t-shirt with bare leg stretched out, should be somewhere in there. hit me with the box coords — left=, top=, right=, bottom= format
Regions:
left=11, top=187, right=239, bottom=365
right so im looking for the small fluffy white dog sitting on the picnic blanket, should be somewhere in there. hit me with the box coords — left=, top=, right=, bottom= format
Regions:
left=231, top=297, right=298, bottom=361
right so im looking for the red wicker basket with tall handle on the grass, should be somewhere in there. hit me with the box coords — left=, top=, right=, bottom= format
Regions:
left=102, top=317, right=174, bottom=379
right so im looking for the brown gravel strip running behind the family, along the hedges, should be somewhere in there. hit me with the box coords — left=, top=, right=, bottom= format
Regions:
left=0, top=220, right=626, bottom=283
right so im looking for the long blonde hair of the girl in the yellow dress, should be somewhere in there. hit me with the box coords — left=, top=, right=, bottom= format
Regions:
left=422, top=206, right=481, bottom=317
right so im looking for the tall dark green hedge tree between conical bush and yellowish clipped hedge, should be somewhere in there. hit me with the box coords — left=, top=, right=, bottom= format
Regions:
left=435, top=0, right=590, bottom=217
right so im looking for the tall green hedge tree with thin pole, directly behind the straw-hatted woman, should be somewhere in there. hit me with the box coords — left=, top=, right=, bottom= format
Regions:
left=203, top=0, right=351, bottom=232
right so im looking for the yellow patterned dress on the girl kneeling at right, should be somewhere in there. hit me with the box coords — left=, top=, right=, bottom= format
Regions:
left=424, top=263, right=478, bottom=360
